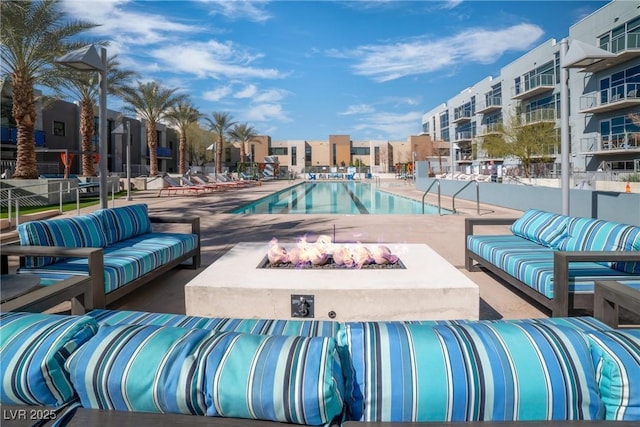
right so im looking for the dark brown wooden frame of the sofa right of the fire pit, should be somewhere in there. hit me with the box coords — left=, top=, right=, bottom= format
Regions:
left=464, top=218, right=640, bottom=317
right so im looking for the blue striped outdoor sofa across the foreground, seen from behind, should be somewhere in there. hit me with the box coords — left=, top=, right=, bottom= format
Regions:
left=0, top=310, right=640, bottom=426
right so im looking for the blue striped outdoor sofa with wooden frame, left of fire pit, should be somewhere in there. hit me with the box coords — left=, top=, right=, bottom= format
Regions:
left=1, top=204, right=200, bottom=308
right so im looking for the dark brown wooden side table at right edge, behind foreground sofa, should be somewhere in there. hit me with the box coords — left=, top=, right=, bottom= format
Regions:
left=593, top=280, right=640, bottom=328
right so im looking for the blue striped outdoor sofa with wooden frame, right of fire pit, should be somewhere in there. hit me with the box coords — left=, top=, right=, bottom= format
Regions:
left=465, top=209, right=640, bottom=316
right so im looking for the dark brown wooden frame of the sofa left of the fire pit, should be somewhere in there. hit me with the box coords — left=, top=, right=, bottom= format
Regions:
left=0, top=215, right=201, bottom=308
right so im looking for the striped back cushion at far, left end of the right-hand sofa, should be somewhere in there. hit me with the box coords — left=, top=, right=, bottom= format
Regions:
left=511, top=209, right=569, bottom=248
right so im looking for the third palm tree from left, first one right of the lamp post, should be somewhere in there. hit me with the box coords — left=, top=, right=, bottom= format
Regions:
left=121, top=82, right=186, bottom=176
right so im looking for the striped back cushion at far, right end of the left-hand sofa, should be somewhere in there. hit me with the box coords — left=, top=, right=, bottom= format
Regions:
left=94, top=203, right=151, bottom=245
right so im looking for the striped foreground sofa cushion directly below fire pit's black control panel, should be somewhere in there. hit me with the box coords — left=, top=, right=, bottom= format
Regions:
left=206, top=334, right=344, bottom=425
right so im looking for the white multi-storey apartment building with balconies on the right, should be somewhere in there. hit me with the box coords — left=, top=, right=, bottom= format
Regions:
left=422, top=0, right=640, bottom=174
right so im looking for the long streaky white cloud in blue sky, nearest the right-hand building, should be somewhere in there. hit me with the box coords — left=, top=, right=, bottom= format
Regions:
left=336, top=24, right=543, bottom=82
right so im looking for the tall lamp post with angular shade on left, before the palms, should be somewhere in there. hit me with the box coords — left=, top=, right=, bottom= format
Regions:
left=55, top=45, right=109, bottom=209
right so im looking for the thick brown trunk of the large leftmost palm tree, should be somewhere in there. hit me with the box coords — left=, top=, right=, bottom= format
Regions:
left=11, top=70, right=39, bottom=179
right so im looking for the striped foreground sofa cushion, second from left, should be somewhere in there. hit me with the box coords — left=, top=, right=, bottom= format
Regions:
left=65, top=325, right=238, bottom=415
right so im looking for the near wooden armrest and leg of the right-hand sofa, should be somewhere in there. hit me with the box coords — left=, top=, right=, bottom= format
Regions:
left=552, top=251, right=640, bottom=317
